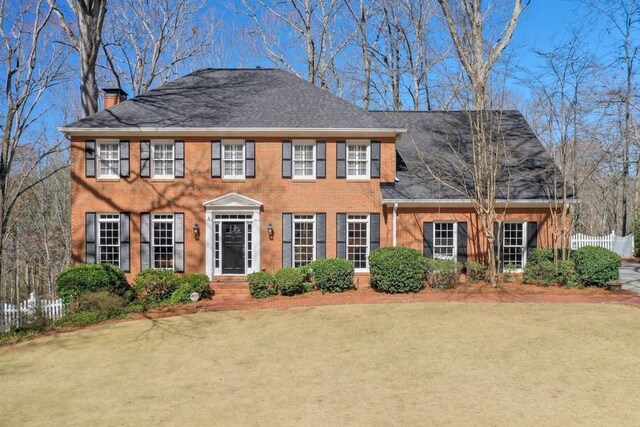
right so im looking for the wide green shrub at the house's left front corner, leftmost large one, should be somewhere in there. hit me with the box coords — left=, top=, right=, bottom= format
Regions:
left=56, top=264, right=134, bottom=303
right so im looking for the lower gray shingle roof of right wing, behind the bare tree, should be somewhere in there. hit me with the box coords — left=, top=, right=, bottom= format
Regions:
left=373, top=111, right=562, bottom=200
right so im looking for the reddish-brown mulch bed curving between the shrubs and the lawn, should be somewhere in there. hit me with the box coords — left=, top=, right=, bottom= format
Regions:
left=138, top=283, right=640, bottom=319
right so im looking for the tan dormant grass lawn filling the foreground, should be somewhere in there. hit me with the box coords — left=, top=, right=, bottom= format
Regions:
left=0, top=303, right=640, bottom=425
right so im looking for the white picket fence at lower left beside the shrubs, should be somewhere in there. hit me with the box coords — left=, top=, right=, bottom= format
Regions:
left=0, top=292, right=64, bottom=333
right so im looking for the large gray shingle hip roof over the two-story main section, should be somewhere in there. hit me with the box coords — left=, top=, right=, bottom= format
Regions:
left=67, top=69, right=396, bottom=129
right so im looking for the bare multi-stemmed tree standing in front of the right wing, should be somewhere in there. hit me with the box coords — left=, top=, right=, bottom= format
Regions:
left=438, top=0, right=528, bottom=286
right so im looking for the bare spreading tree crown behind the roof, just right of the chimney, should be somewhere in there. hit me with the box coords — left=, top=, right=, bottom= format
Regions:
left=103, top=0, right=211, bottom=95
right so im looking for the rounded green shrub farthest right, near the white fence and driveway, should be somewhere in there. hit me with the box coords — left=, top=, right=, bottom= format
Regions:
left=573, top=246, right=622, bottom=286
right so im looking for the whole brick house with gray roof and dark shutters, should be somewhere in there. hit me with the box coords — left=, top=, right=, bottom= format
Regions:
left=62, top=69, right=555, bottom=281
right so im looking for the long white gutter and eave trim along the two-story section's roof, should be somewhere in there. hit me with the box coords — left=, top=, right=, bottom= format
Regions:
left=58, top=126, right=407, bottom=138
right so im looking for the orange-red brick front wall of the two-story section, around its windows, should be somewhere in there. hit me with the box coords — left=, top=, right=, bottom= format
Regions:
left=71, top=135, right=395, bottom=275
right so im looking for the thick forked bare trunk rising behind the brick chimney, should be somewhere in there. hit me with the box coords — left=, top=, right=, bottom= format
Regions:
left=48, top=0, right=107, bottom=117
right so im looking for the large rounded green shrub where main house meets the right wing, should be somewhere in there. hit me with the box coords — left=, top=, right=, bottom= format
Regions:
left=369, top=248, right=425, bottom=294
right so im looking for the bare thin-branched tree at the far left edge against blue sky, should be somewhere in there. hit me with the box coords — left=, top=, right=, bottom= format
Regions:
left=0, top=0, right=66, bottom=300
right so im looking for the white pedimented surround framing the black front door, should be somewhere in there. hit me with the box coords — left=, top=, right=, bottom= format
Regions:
left=203, top=193, right=262, bottom=278
